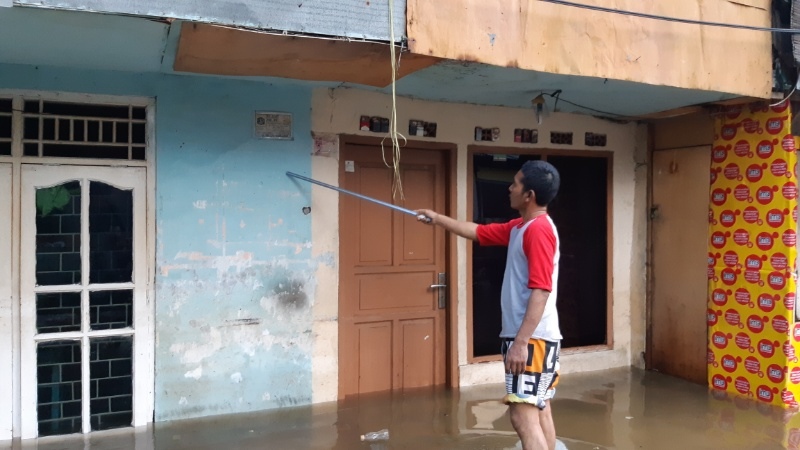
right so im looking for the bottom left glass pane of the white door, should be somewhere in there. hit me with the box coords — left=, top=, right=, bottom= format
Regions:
left=36, top=341, right=82, bottom=436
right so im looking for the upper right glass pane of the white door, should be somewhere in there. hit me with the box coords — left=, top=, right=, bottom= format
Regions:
left=89, top=182, right=133, bottom=283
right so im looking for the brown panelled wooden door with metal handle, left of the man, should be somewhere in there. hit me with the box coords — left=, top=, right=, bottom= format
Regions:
left=339, top=144, right=447, bottom=398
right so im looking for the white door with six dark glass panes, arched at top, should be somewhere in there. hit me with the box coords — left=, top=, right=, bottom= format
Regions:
left=20, top=165, right=148, bottom=438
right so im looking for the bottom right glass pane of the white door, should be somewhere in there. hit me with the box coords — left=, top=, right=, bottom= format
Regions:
left=89, top=336, right=133, bottom=430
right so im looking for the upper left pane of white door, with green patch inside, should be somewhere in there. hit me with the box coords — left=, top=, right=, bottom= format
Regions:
left=36, top=181, right=81, bottom=286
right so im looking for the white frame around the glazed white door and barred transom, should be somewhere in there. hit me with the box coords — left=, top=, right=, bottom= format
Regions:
left=0, top=89, right=156, bottom=440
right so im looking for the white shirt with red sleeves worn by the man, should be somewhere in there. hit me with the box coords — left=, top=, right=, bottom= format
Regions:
left=477, top=214, right=561, bottom=341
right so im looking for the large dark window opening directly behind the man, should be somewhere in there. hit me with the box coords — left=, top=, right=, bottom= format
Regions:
left=472, top=153, right=610, bottom=357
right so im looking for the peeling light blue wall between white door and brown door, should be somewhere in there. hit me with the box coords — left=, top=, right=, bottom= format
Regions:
left=0, top=64, right=316, bottom=421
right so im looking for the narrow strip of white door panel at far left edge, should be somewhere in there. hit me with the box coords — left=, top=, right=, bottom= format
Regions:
left=0, top=164, right=14, bottom=441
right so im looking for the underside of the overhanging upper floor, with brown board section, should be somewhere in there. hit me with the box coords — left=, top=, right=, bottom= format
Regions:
left=0, top=7, right=752, bottom=118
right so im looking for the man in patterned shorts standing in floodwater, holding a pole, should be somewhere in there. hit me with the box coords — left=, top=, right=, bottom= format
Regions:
left=416, top=161, right=561, bottom=450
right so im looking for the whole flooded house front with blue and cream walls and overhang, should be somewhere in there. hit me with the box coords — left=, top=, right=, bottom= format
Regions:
left=0, top=0, right=772, bottom=440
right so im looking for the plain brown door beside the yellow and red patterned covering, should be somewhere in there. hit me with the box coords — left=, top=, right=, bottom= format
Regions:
left=649, top=147, right=711, bottom=384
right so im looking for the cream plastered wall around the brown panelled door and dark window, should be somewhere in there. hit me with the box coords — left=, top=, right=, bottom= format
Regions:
left=311, top=88, right=647, bottom=403
